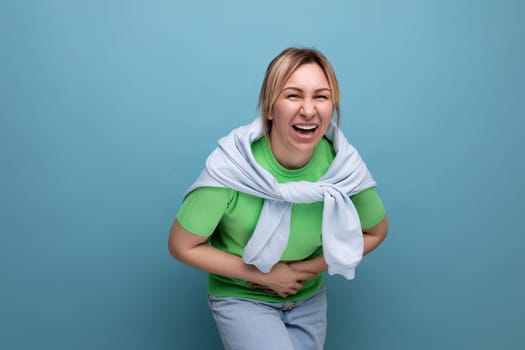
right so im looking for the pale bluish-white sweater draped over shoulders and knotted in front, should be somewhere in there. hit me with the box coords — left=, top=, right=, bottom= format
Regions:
left=187, top=117, right=376, bottom=279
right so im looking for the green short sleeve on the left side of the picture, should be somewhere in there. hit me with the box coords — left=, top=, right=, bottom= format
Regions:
left=177, top=187, right=230, bottom=236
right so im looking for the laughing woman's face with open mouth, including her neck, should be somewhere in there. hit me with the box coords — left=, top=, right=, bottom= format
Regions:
left=268, top=63, right=334, bottom=169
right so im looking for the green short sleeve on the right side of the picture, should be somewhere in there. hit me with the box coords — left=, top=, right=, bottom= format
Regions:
left=350, top=187, right=385, bottom=229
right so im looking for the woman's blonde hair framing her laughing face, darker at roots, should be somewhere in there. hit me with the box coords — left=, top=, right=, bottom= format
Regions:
left=257, top=47, right=341, bottom=134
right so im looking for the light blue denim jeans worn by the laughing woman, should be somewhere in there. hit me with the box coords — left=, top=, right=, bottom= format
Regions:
left=208, top=286, right=326, bottom=350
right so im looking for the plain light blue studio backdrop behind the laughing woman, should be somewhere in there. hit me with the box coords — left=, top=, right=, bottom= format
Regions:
left=0, top=0, right=525, bottom=349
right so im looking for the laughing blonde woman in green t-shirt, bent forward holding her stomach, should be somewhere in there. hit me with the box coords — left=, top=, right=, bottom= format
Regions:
left=169, top=48, right=387, bottom=350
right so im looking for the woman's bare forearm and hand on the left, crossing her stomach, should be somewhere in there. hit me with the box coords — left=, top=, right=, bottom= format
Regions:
left=168, top=220, right=315, bottom=297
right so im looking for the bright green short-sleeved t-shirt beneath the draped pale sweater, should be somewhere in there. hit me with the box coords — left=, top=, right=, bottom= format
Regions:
left=177, top=137, right=385, bottom=301
